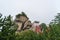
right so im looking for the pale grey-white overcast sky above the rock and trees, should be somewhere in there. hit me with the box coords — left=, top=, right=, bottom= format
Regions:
left=0, top=0, right=60, bottom=24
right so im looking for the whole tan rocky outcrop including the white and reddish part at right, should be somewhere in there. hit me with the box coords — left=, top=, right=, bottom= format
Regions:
left=15, top=14, right=41, bottom=33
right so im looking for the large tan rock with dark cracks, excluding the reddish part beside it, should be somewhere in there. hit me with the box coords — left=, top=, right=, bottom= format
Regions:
left=15, top=14, right=31, bottom=31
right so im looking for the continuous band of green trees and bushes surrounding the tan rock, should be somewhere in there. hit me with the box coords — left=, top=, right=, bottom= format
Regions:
left=0, top=14, right=60, bottom=40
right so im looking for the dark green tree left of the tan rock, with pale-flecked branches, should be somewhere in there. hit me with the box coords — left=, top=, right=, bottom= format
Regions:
left=0, top=15, right=17, bottom=40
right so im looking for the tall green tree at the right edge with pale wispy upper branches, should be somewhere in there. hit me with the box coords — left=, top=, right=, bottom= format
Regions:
left=50, top=13, right=60, bottom=40
